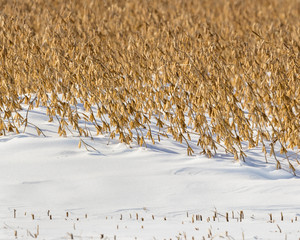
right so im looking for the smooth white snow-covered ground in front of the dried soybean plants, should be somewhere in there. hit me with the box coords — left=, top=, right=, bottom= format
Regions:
left=0, top=108, right=300, bottom=240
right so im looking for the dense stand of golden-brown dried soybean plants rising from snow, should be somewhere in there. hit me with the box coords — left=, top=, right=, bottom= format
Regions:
left=0, top=0, right=300, bottom=173
